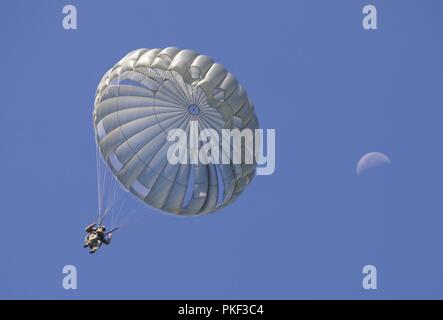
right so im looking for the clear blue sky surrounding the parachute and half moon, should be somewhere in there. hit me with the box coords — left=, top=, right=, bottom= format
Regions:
left=0, top=0, right=443, bottom=299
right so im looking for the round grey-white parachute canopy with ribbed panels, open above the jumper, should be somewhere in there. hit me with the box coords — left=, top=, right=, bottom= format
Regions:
left=93, top=47, right=258, bottom=220
